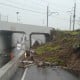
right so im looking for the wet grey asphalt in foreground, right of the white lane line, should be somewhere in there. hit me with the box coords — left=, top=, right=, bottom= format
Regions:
left=24, top=66, right=80, bottom=80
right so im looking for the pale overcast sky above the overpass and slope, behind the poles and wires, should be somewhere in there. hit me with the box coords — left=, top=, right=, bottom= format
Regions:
left=0, top=0, right=80, bottom=30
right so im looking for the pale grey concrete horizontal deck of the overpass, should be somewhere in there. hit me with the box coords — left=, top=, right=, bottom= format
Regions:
left=0, top=21, right=52, bottom=35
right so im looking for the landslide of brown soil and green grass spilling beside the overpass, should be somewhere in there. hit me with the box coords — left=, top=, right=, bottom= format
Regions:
left=35, top=31, right=80, bottom=70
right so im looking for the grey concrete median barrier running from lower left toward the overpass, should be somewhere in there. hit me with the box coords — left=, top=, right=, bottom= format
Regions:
left=0, top=51, right=25, bottom=80
